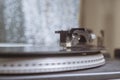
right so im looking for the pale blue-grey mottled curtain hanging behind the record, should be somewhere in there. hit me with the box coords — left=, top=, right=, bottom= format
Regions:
left=3, top=0, right=80, bottom=45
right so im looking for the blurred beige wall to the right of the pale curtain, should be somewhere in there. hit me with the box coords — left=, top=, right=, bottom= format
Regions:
left=80, top=0, right=120, bottom=57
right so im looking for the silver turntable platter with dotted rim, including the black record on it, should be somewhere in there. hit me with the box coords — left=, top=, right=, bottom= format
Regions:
left=0, top=46, right=105, bottom=74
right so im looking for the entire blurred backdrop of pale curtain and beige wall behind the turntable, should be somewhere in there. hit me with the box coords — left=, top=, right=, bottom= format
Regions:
left=0, top=0, right=120, bottom=57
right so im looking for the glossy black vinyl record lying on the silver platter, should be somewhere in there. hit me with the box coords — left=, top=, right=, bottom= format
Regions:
left=0, top=46, right=100, bottom=56
